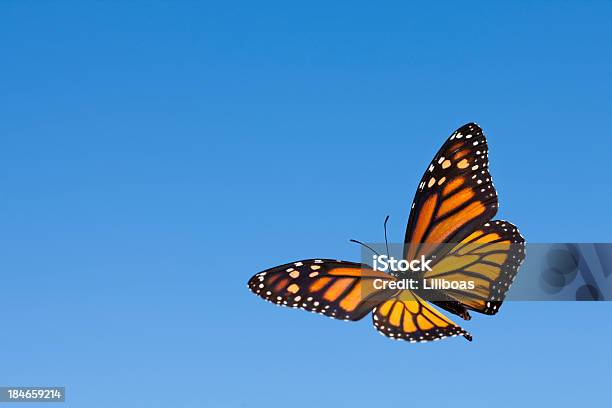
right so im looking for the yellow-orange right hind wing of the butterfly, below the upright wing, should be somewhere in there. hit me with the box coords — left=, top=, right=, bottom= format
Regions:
left=424, top=220, right=525, bottom=315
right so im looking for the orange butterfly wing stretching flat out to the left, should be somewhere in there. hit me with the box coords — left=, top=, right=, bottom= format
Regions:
left=248, top=259, right=397, bottom=320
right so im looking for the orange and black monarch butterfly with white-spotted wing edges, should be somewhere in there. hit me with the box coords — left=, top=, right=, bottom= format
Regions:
left=248, top=123, right=525, bottom=342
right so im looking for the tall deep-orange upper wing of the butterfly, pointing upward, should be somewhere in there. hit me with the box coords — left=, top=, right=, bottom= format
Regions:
left=404, top=123, right=497, bottom=259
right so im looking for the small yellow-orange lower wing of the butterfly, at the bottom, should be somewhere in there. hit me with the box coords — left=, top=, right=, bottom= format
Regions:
left=372, top=290, right=472, bottom=342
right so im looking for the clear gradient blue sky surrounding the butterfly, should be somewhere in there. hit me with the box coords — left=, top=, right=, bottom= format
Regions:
left=0, top=1, right=612, bottom=407
